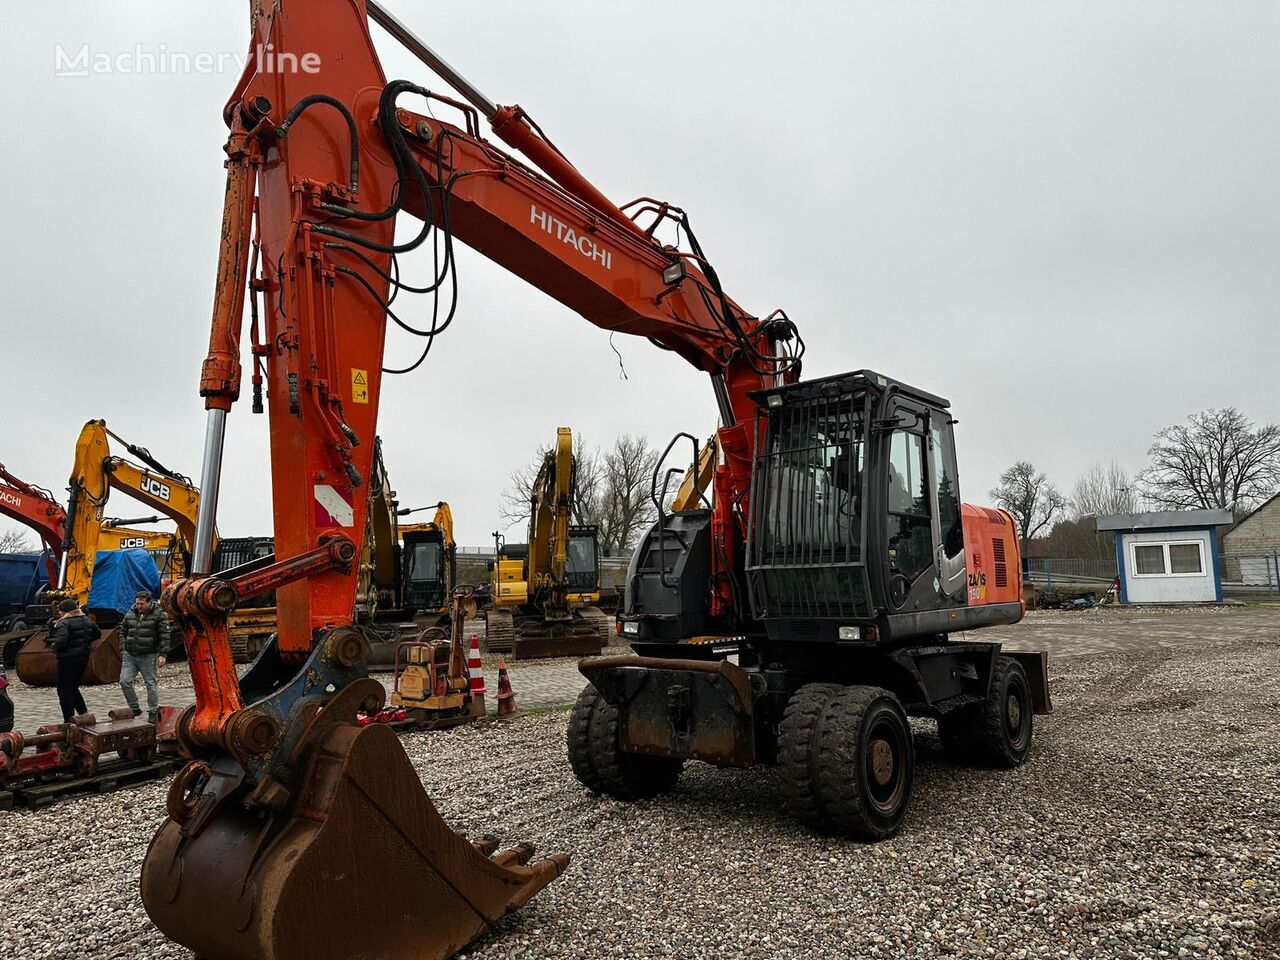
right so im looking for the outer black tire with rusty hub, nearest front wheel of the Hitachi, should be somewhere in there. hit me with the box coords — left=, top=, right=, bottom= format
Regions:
left=815, top=686, right=915, bottom=840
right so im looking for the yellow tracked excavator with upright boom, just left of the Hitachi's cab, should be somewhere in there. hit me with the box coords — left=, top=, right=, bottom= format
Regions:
left=485, top=426, right=612, bottom=660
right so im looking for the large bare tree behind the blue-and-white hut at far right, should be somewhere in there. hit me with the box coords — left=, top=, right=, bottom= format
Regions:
left=1139, top=407, right=1280, bottom=511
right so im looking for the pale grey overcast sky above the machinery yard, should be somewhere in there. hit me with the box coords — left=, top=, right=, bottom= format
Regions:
left=0, top=0, right=1280, bottom=545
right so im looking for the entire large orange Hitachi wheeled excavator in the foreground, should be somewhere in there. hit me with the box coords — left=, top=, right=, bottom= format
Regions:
left=142, top=0, right=1048, bottom=960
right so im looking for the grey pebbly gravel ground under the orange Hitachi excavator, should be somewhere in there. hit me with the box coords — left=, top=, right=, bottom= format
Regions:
left=0, top=612, right=1280, bottom=960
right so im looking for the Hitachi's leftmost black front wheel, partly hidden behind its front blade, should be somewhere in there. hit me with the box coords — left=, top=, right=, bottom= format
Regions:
left=568, top=684, right=685, bottom=800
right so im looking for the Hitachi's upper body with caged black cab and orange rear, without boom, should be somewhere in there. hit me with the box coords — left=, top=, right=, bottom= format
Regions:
left=622, top=370, right=1023, bottom=654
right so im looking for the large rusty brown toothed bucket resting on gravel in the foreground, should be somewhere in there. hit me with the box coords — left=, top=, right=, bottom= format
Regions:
left=142, top=681, right=568, bottom=960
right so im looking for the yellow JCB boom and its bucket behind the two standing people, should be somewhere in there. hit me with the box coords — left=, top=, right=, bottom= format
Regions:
left=15, top=420, right=200, bottom=686
